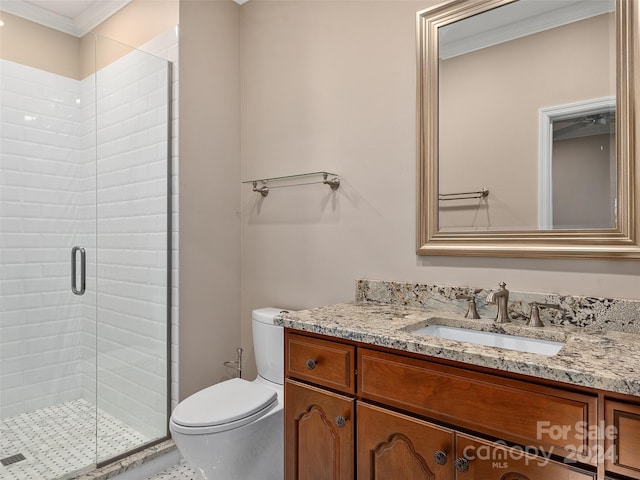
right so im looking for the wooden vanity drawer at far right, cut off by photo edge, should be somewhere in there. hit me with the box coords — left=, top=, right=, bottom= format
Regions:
left=604, top=400, right=640, bottom=478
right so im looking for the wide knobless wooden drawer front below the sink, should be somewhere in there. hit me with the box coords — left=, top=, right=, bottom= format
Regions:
left=358, top=349, right=597, bottom=464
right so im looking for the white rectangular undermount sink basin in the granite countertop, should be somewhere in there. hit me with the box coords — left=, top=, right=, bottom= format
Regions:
left=412, top=324, right=564, bottom=356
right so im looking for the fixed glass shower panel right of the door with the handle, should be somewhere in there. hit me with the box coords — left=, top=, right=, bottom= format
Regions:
left=96, top=37, right=171, bottom=463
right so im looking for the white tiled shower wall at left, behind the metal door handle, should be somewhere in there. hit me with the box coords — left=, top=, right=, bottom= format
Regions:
left=0, top=60, right=86, bottom=418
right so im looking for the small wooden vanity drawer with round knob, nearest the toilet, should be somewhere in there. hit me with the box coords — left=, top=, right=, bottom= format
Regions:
left=285, top=332, right=355, bottom=393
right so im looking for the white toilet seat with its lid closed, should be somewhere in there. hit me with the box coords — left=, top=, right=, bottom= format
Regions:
left=171, top=378, right=278, bottom=435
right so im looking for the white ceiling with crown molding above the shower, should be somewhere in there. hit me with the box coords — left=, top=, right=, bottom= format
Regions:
left=0, top=0, right=131, bottom=37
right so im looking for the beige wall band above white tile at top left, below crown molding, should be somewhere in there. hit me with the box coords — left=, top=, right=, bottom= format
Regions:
left=0, top=12, right=81, bottom=80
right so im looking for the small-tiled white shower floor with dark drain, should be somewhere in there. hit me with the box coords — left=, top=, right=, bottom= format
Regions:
left=0, top=400, right=149, bottom=480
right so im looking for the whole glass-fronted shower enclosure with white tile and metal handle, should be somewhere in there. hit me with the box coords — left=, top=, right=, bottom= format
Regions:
left=0, top=31, right=171, bottom=480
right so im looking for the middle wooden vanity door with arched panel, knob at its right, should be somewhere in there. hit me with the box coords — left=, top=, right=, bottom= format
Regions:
left=356, top=402, right=454, bottom=480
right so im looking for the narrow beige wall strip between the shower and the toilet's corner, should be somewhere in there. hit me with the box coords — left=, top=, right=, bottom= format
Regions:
left=179, top=0, right=240, bottom=399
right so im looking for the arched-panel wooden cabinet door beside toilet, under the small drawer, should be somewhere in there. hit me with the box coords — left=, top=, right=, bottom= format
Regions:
left=284, top=379, right=355, bottom=480
